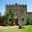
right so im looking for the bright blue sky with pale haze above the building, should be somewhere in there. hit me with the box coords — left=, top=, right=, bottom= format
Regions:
left=0, top=0, right=32, bottom=15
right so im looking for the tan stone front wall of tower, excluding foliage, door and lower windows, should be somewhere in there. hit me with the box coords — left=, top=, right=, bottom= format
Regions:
left=6, top=3, right=27, bottom=24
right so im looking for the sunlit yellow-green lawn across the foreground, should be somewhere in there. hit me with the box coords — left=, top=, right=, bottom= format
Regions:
left=0, top=25, right=32, bottom=32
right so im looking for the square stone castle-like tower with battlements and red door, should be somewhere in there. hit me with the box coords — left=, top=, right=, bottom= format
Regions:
left=6, top=3, right=27, bottom=25
